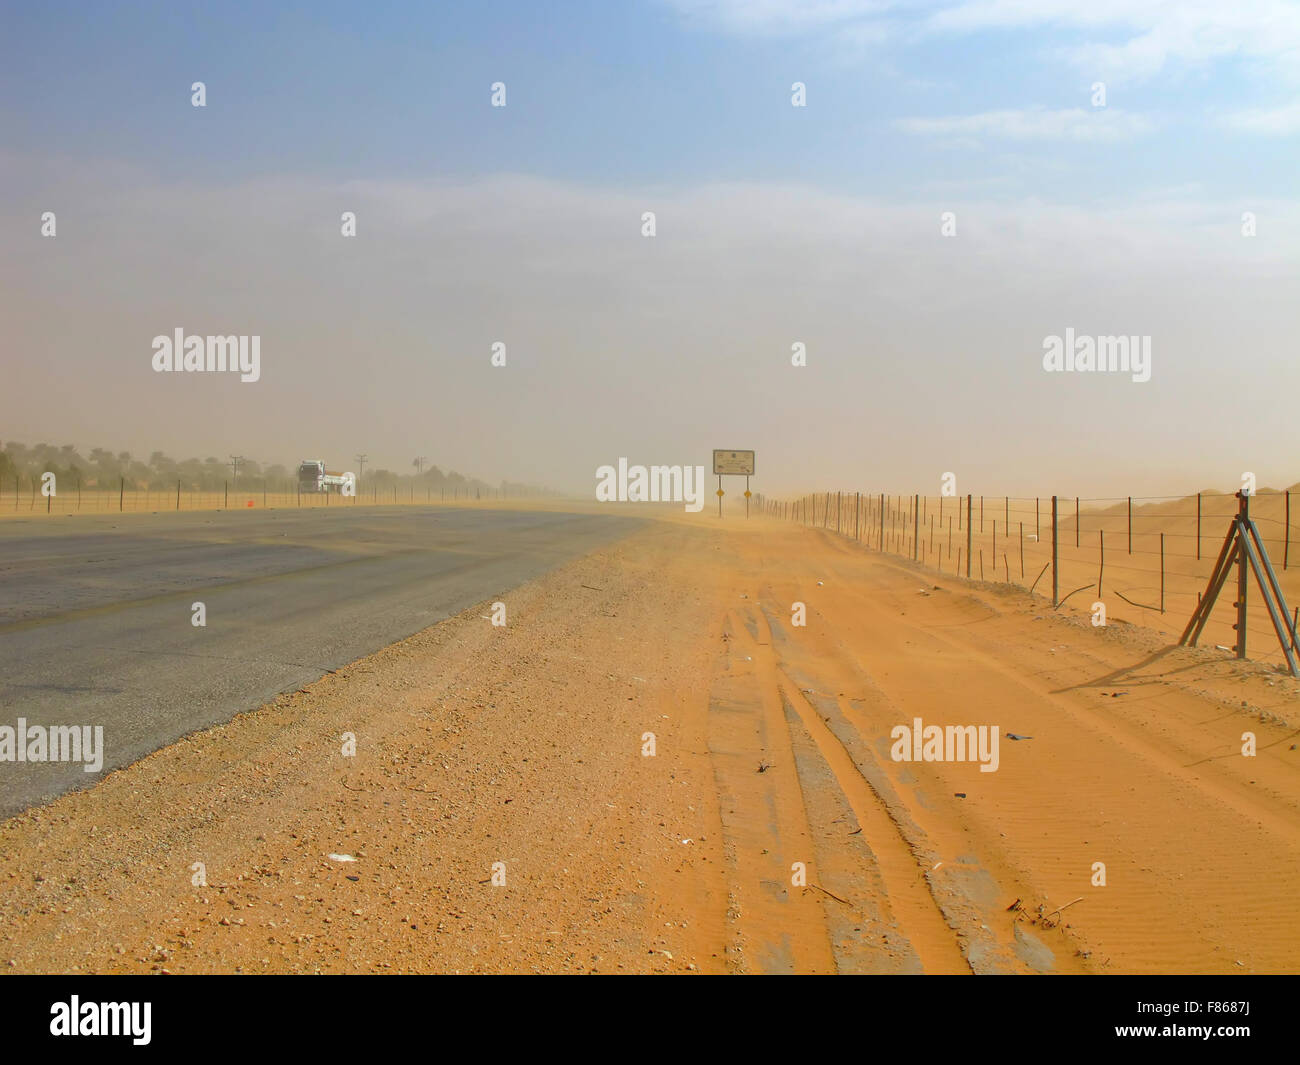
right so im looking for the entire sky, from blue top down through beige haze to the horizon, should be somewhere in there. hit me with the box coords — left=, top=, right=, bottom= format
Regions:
left=0, top=0, right=1300, bottom=495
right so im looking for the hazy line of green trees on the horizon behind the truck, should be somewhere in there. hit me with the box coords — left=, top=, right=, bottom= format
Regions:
left=0, top=441, right=554, bottom=499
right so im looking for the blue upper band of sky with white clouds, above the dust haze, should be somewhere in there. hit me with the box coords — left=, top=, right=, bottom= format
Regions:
left=10, top=0, right=1300, bottom=202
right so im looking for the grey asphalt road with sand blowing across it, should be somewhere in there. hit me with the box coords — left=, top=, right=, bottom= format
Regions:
left=0, top=507, right=640, bottom=817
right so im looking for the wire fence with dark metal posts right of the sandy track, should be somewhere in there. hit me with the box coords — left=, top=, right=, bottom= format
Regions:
left=759, top=490, right=1300, bottom=662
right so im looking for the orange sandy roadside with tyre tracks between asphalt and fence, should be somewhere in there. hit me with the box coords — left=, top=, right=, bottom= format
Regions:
left=0, top=506, right=1300, bottom=973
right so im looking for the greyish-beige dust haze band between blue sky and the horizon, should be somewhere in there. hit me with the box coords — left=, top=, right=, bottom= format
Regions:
left=0, top=156, right=1300, bottom=497
